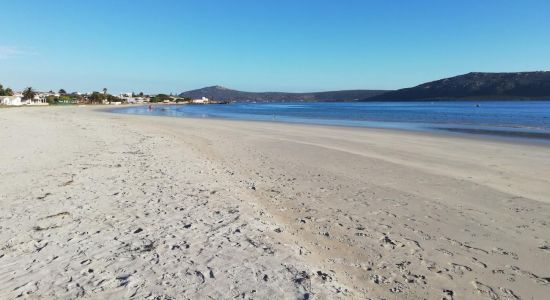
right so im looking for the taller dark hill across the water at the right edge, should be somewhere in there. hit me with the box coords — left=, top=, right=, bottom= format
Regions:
left=363, top=72, right=550, bottom=101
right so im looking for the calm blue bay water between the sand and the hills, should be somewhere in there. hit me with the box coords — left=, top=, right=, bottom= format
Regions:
left=113, top=101, right=550, bottom=141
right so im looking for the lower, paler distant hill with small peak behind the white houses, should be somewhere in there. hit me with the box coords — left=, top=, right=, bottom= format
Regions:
left=179, top=86, right=386, bottom=102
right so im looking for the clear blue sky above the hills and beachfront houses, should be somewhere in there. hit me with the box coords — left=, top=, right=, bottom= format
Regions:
left=0, top=0, right=550, bottom=93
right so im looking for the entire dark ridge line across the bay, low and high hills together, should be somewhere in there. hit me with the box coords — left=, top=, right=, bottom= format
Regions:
left=179, top=71, right=550, bottom=102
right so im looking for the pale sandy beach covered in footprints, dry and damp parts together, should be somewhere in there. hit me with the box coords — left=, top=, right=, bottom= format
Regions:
left=0, top=107, right=550, bottom=299
